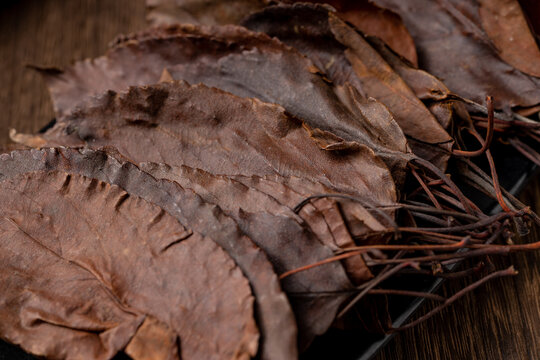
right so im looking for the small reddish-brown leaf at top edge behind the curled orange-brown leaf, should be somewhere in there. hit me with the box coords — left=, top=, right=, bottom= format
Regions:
left=283, top=0, right=417, bottom=65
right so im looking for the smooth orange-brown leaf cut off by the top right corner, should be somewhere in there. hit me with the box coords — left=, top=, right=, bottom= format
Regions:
left=478, top=0, right=540, bottom=77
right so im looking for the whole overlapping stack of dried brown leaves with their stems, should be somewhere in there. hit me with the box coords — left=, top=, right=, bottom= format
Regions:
left=0, top=0, right=540, bottom=359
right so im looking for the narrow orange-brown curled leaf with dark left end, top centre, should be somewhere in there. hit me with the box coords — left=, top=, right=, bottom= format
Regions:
left=243, top=4, right=452, bottom=145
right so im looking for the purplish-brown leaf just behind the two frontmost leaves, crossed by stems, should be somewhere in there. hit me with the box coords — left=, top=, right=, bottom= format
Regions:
left=136, top=163, right=362, bottom=350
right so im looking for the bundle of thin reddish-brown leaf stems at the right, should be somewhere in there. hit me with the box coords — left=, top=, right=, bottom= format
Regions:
left=280, top=96, right=540, bottom=333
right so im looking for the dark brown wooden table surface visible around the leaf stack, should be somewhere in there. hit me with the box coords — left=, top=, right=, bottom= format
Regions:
left=0, top=0, right=540, bottom=360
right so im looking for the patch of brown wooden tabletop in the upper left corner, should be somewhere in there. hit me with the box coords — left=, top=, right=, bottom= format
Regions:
left=0, top=0, right=145, bottom=143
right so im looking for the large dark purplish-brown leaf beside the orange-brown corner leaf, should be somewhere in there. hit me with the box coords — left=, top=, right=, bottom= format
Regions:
left=374, top=0, right=540, bottom=108
